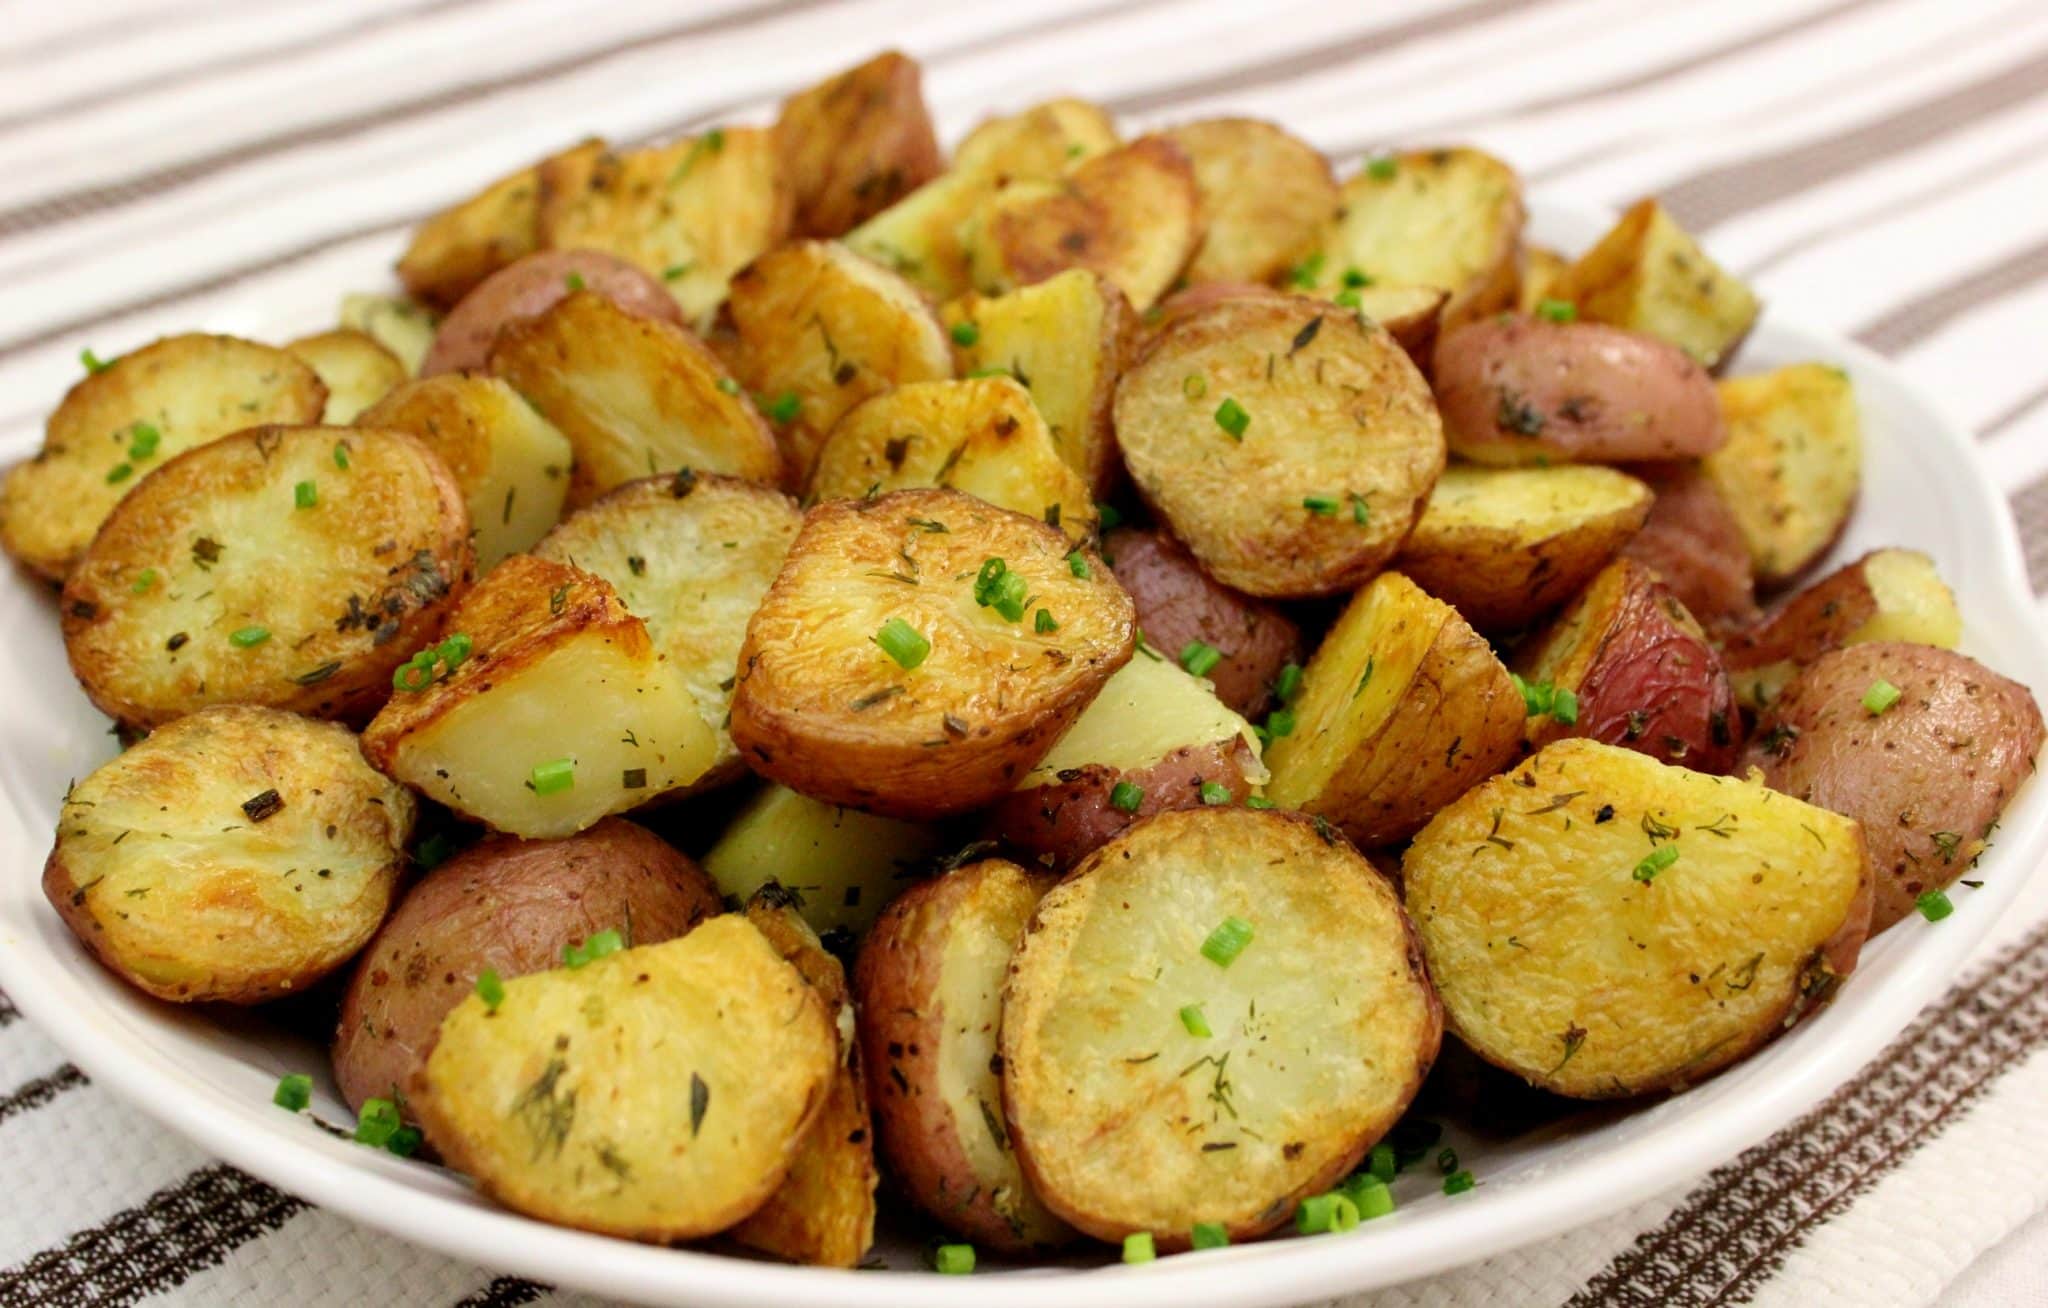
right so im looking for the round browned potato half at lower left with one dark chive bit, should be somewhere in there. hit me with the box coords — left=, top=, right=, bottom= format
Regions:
left=43, top=704, right=414, bottom=1003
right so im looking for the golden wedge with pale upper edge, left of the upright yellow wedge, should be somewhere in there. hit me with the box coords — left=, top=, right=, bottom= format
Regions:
left=729, top=242, right=952, bottom=485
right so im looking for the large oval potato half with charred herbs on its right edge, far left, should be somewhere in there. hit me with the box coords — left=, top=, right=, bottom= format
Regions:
left=61, top=428, right=471, bottom=727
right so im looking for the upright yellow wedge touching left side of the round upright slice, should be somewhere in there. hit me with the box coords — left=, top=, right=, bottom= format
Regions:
left=946, top=268, right=1137, bottom=497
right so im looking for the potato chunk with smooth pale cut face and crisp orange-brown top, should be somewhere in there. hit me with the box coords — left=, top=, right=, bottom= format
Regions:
left=362, top=555, right=719, bottom=837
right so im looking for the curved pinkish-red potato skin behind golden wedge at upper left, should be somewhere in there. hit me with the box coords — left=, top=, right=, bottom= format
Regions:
left=420, top=250, right=684, bottom=377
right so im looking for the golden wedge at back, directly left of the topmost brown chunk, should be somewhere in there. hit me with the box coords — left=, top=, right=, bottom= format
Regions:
left=539, top=127, right=793, bottom=332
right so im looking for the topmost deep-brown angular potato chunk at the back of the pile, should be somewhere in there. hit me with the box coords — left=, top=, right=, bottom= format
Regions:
left=774, top=49, right=946, bottom=237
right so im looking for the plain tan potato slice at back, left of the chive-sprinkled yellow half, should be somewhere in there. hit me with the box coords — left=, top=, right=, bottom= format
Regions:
left=1159, top=119, right=1337, bottom=287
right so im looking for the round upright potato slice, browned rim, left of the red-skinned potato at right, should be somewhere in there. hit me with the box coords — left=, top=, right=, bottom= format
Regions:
left=1116, top=297, right=1444, bottom=598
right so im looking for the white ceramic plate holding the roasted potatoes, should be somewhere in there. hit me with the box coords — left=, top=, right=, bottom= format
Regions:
left=0, top=205, right=2048, bottom=1308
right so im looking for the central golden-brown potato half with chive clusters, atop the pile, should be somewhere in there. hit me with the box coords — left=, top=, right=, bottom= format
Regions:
left=731, top=491, right=1133, bottom=819
